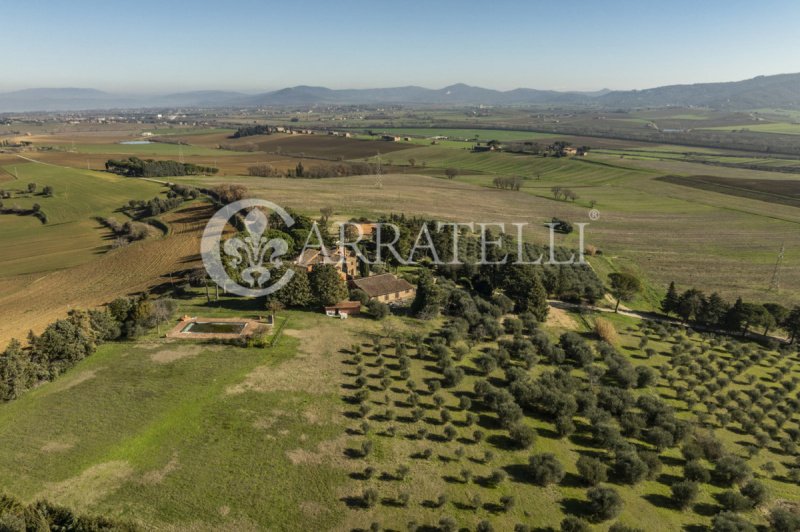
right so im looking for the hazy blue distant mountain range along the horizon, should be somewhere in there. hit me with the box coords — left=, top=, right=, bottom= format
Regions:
left=0, top=74, right=800, bottom=112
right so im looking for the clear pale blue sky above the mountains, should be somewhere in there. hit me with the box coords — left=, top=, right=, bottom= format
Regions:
left=0, top=0, right=800, bottom=94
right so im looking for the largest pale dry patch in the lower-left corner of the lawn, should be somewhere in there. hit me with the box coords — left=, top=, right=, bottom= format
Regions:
left=37, top=460, right=133, bottom=509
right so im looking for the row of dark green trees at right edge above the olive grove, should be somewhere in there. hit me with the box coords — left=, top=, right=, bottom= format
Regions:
left=661, top=282, right=800, bottom=343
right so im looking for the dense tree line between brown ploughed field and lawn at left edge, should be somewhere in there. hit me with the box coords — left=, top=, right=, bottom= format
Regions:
left=0, top=296, right=176, bottom=401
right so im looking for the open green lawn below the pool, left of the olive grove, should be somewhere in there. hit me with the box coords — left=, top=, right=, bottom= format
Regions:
left=0, top=302, right=356, bottom=530
